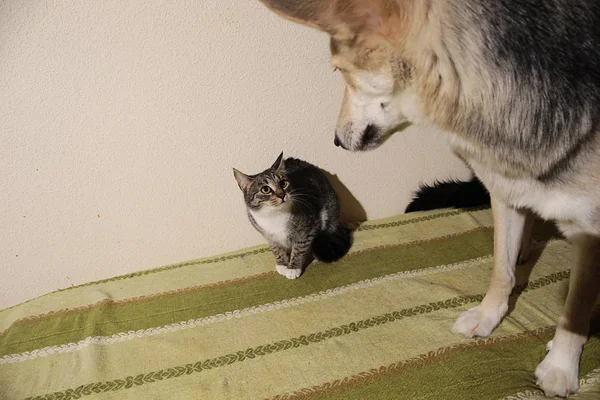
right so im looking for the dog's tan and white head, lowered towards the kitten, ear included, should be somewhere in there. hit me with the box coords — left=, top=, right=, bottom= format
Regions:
left=255, top=0, right=411, bottom=151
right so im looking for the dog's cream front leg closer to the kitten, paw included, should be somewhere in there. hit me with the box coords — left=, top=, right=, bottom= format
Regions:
left=452, top=197, right=527, bottom=337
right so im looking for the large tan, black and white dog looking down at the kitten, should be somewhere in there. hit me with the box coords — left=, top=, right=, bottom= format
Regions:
left=255, top=0, right=600, bottom=397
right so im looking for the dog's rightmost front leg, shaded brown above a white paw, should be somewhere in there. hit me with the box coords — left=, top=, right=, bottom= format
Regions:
left=535, top=231, right=600, bottom=397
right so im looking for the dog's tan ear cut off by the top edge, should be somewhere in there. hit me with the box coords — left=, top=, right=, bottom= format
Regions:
left=260, top=0, right=398, bottom=39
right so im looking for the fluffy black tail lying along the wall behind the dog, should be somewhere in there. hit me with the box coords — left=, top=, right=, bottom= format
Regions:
left=404, top=177, right=490, bottom=213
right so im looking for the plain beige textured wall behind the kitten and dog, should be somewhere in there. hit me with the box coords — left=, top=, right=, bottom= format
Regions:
left=0, top=0, right=468, bottom=308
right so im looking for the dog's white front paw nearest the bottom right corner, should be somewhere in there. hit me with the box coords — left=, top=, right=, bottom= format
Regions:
left=535, top=354, right=579, bottom=397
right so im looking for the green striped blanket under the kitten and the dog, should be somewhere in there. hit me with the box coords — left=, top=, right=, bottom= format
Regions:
left=0, top=209, right=600, bottom=400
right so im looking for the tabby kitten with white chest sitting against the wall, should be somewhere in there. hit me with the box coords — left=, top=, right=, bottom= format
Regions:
left=233, top=153, right=352, bottom=279
